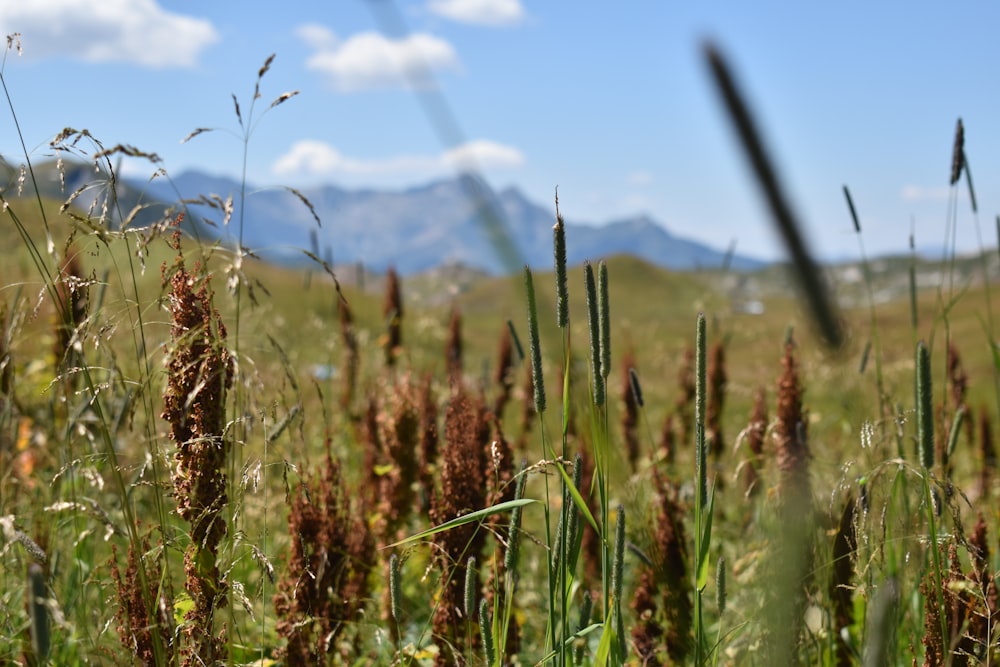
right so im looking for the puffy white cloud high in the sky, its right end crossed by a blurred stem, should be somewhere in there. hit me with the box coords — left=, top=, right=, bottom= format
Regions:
left=300, top=26, right=461, bottom=91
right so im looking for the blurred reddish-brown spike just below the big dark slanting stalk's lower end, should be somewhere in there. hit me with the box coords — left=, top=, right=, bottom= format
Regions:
left=774, top=342, right=812, bottom=512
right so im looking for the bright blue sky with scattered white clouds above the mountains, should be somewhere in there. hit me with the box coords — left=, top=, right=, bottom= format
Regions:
left=0, top=0, right=1000, bottom=259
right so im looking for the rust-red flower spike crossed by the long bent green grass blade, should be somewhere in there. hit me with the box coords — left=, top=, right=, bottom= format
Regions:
left=431, top=387, right=486, bottom=665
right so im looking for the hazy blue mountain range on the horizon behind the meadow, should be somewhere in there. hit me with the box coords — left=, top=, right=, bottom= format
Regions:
left=13, top=163, right=766, bottom=274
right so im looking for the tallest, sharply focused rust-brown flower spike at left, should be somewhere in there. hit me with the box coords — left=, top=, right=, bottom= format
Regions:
left=162, top=262, right=232, bottom=665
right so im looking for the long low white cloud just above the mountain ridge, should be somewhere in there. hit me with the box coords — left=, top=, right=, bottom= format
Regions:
left=273, top=139, right=524, bottom=177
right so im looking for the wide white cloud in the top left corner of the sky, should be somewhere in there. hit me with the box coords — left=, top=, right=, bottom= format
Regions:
left=0, top=0, right=219, bottom=68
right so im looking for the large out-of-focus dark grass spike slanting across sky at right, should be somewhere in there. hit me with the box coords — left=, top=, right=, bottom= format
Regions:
left=705, top=43, right=844, bottom=348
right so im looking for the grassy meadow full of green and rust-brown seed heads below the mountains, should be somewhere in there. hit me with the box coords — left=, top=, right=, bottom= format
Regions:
left=0, top=53, right=1000, bottom=665
